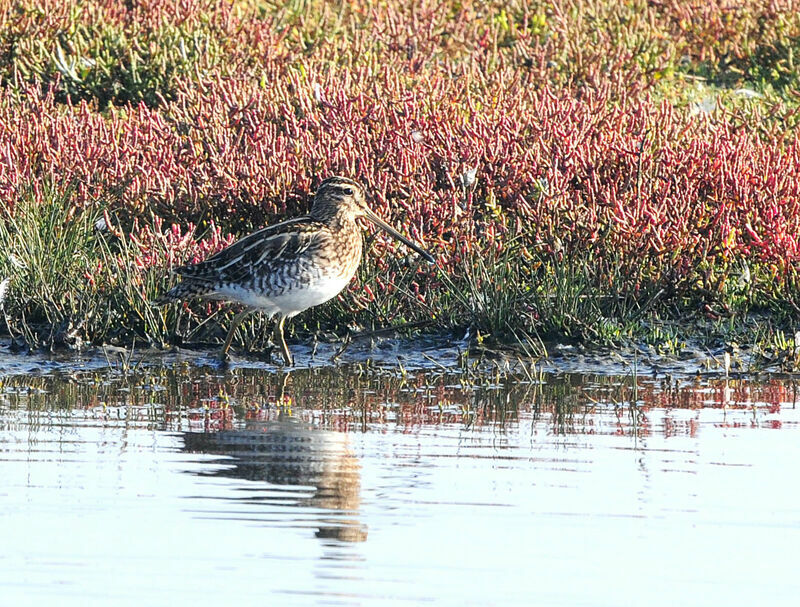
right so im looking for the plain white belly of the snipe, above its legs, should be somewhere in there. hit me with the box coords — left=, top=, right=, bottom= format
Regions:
left=218, top=276, right=352, bottom=318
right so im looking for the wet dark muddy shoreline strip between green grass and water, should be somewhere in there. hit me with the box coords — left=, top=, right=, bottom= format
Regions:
left=0, top=335, right=796, bottom=378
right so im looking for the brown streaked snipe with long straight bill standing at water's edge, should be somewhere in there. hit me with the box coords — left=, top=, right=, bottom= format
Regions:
left=155, top=177, right=434, bottom=366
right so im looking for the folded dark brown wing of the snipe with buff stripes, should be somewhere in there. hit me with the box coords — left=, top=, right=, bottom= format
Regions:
left=175, top=216, right=327, bottom=282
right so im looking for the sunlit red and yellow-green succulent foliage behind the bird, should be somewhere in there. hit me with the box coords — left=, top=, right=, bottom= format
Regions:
left=0, top=0, right=800, bottom=342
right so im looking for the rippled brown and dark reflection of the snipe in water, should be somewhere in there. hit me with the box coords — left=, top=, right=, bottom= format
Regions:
left=183, top=376, right=367, bottom=542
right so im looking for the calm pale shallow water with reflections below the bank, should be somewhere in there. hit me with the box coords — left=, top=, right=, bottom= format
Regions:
left=0, top=352, right=800, bottom=606
